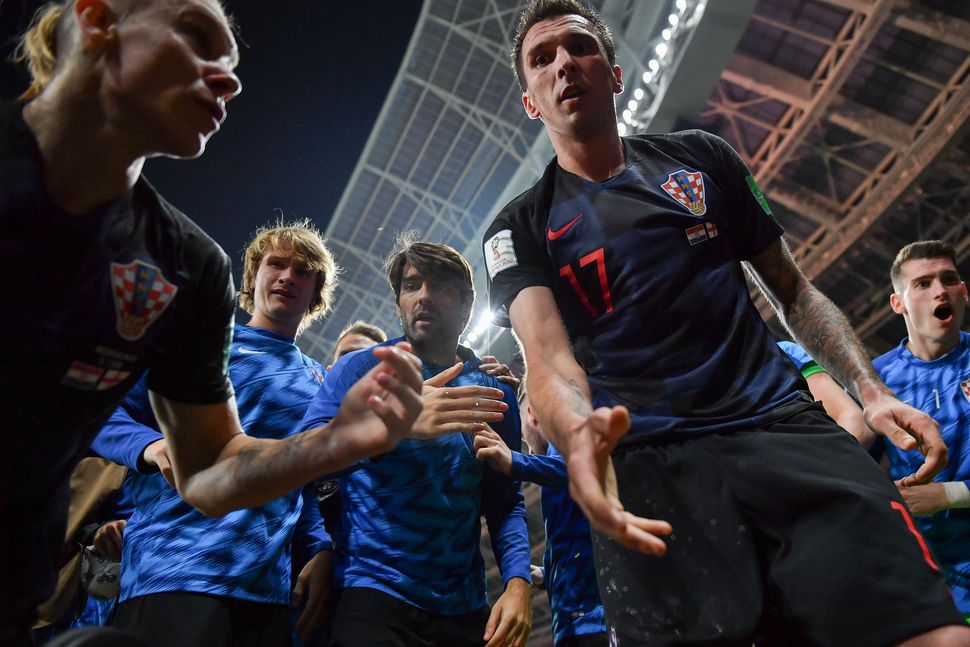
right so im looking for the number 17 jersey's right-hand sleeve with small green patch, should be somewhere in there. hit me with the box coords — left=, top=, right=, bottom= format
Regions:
left=690, top=130, right=784, bottom=261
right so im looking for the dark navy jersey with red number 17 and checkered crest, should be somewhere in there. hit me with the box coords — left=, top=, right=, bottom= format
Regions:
left=484, top=131, right=810, bottom=440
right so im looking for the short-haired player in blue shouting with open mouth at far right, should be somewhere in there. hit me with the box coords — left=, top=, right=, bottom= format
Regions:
left=873, top=240, right=970, bottom=620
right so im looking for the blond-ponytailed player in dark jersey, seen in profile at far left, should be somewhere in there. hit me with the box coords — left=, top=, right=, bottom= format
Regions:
left=0, top=0, right=421, bottom=645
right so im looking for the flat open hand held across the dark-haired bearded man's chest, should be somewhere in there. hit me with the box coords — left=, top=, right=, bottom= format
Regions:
left=411, top=362, right=509, bottom=439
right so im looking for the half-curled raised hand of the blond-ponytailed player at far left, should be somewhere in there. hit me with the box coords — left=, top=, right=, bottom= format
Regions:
left=330, top=342, right=422, bottom=462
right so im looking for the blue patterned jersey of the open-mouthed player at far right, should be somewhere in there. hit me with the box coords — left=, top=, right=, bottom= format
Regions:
left=872, top=332, right=970, bottom=614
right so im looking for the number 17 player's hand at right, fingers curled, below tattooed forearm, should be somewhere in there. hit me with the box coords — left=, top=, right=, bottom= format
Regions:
left=862, top=394, right=947, bottom=487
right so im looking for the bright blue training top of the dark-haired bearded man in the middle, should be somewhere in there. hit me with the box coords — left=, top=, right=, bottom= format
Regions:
left=301, top=338, right=531, bottom=615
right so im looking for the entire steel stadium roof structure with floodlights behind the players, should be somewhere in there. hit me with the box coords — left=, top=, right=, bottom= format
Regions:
left=302, top=0, right=970, bottom=645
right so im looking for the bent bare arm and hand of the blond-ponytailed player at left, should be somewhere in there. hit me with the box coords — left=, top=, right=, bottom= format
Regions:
left=149, top=346, right=422, bottom=516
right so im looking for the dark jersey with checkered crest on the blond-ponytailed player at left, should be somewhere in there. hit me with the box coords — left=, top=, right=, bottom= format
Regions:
left=0, top=102, right=235, bottom=625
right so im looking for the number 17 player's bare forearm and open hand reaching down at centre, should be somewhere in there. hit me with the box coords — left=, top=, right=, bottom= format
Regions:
left=509, top=286, right=671, bottom=555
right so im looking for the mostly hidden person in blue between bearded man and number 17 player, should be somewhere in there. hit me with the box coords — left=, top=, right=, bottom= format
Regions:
left=475, top=387, right=608, bottom=647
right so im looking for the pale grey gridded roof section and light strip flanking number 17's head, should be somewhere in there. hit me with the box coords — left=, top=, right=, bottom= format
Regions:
left=301, top=0, right=740, bottom=364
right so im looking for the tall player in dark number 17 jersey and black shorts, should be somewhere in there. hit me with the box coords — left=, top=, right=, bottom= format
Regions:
left=483, top=0, right=970, bottom=645
